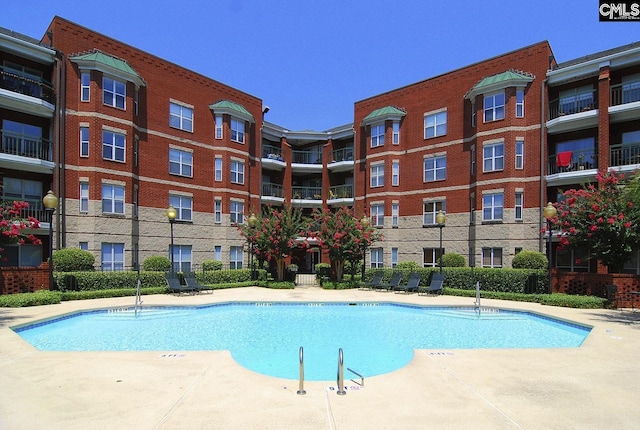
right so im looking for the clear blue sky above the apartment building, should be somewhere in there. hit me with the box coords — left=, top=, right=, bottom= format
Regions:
left=0, top=0, right=640, bottom=131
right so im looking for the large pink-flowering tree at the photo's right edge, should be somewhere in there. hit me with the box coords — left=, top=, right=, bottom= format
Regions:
left=552, top=172, right=640, bottom=273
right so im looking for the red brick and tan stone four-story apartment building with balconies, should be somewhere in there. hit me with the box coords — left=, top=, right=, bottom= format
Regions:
left=0, top=17, right=640, bottom=273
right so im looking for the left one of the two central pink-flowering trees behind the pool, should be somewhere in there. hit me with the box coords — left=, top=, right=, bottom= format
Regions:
left=237, top=206, right=305, bottom=281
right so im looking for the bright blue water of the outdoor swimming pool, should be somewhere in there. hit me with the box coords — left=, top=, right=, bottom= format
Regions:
left=14, top=303, right=590, bottom=381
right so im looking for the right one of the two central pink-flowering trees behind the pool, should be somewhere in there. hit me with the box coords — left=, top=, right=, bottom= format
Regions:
left=307, top=207, right=382, bottom=282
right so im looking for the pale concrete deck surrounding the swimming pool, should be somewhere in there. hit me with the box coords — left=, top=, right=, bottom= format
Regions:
left=0, top=287, right=640, bottom=430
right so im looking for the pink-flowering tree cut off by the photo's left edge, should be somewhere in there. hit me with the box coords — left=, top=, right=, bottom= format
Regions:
left=0, top=201, right=42, bottom=258
